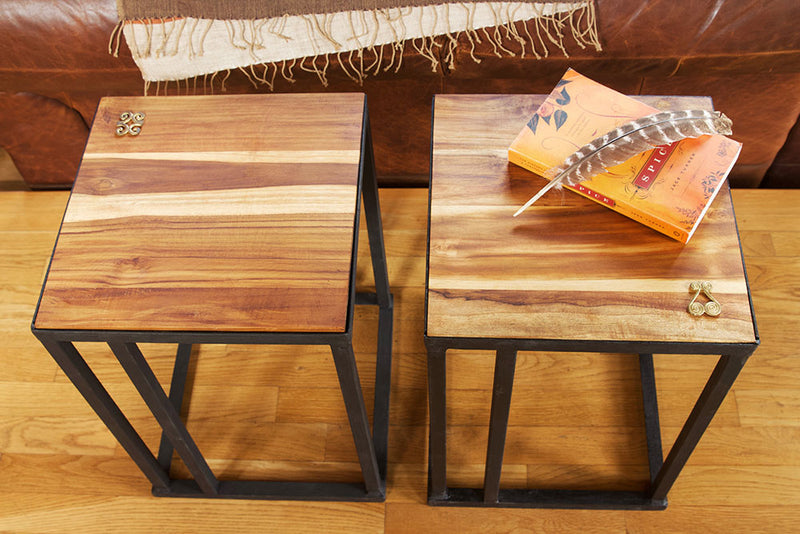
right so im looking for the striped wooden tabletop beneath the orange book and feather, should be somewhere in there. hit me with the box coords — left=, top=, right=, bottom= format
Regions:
left=426, top=95, right=755, bottom=343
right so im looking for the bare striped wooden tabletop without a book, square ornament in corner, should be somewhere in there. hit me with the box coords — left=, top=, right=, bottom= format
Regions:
left=34, top=94, right=364, bottom=332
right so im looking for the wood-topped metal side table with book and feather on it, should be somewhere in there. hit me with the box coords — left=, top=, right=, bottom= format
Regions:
left=425, top=95, right=759, bottom=509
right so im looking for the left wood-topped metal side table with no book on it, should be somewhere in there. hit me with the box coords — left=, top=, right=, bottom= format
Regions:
left=33, top=94, right=392, bottom=501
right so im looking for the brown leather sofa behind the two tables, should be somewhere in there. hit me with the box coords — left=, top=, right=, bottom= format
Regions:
left=0, top=0, right=800, bottom=188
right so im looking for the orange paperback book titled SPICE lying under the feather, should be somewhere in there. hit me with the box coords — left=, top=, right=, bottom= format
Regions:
left=508, top=69, right=742, bottom=243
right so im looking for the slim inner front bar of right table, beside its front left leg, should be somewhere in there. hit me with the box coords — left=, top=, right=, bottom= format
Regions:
left=483, top=347, right=517, bottom=503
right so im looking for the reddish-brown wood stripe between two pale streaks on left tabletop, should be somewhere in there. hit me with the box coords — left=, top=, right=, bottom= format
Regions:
left=73, top=163, right=358, bottom=199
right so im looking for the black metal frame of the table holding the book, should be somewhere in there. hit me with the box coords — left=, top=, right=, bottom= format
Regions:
left=425, top=338, right=758, bottom=510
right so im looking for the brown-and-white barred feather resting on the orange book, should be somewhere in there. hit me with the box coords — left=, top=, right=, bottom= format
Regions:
left=514, top=110, right=732, bottom=217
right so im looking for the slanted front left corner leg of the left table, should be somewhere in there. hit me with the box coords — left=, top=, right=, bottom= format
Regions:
left=39, top=335, right=169, bottom=489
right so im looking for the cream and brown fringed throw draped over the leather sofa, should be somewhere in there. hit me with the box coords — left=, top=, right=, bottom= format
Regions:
left=108, top=0, right=601, bottom=94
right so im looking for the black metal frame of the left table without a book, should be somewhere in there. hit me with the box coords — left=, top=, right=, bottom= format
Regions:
left=32, top=108, right=393, bottom=502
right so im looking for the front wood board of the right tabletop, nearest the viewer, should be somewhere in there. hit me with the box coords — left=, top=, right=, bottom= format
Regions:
left=427, top=289, right=752, bottom=343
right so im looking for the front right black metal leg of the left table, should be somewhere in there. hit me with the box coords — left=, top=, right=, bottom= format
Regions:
left=331, top=342, right=385, bottom=495
